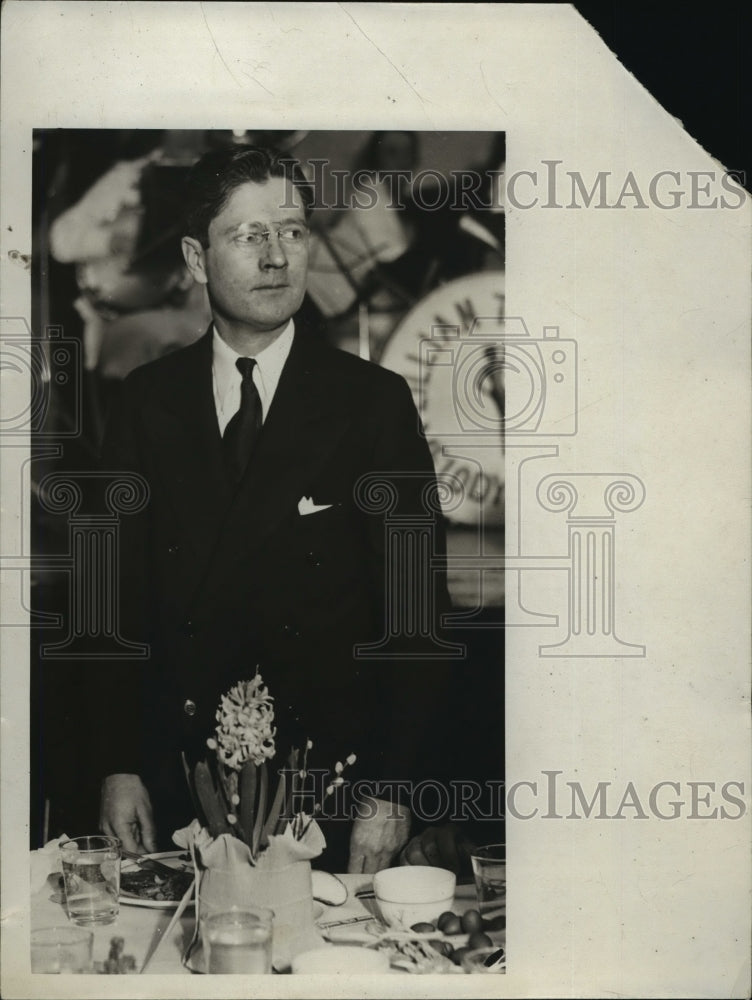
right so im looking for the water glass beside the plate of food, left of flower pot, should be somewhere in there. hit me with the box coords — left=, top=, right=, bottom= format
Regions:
left=60, top=836, right=120, bottom=927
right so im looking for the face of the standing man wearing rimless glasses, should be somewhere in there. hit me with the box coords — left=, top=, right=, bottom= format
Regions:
left=183, top=177, right=308, bottom=333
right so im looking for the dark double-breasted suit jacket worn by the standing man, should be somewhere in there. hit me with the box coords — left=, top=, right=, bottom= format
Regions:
left=101, top=331, right=448, bottom=844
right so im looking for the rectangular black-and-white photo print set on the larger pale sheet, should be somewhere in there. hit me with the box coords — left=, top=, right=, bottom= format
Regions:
left=31, top=129, right=505, bottom=971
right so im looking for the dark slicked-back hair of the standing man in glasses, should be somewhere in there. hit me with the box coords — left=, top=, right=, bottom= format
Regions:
left=184, top=145, right=313, bottom=247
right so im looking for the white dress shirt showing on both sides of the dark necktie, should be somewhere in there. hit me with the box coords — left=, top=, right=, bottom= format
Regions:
left=212, top=320, right=295, bottom=434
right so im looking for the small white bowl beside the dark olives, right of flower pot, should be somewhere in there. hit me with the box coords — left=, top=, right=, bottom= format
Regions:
left=373, top=865, right=457, bottom=930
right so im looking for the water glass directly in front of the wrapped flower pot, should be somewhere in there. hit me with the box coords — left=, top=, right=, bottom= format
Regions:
left=201, top=907, right=274, bottom=975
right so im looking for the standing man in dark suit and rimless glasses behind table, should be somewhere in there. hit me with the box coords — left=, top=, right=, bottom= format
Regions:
left=101, top=146, right=448, bottom=871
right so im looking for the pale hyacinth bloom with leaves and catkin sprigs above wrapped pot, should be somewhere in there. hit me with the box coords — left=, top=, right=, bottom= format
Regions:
left=184, top=670, right=356, bottom=864
